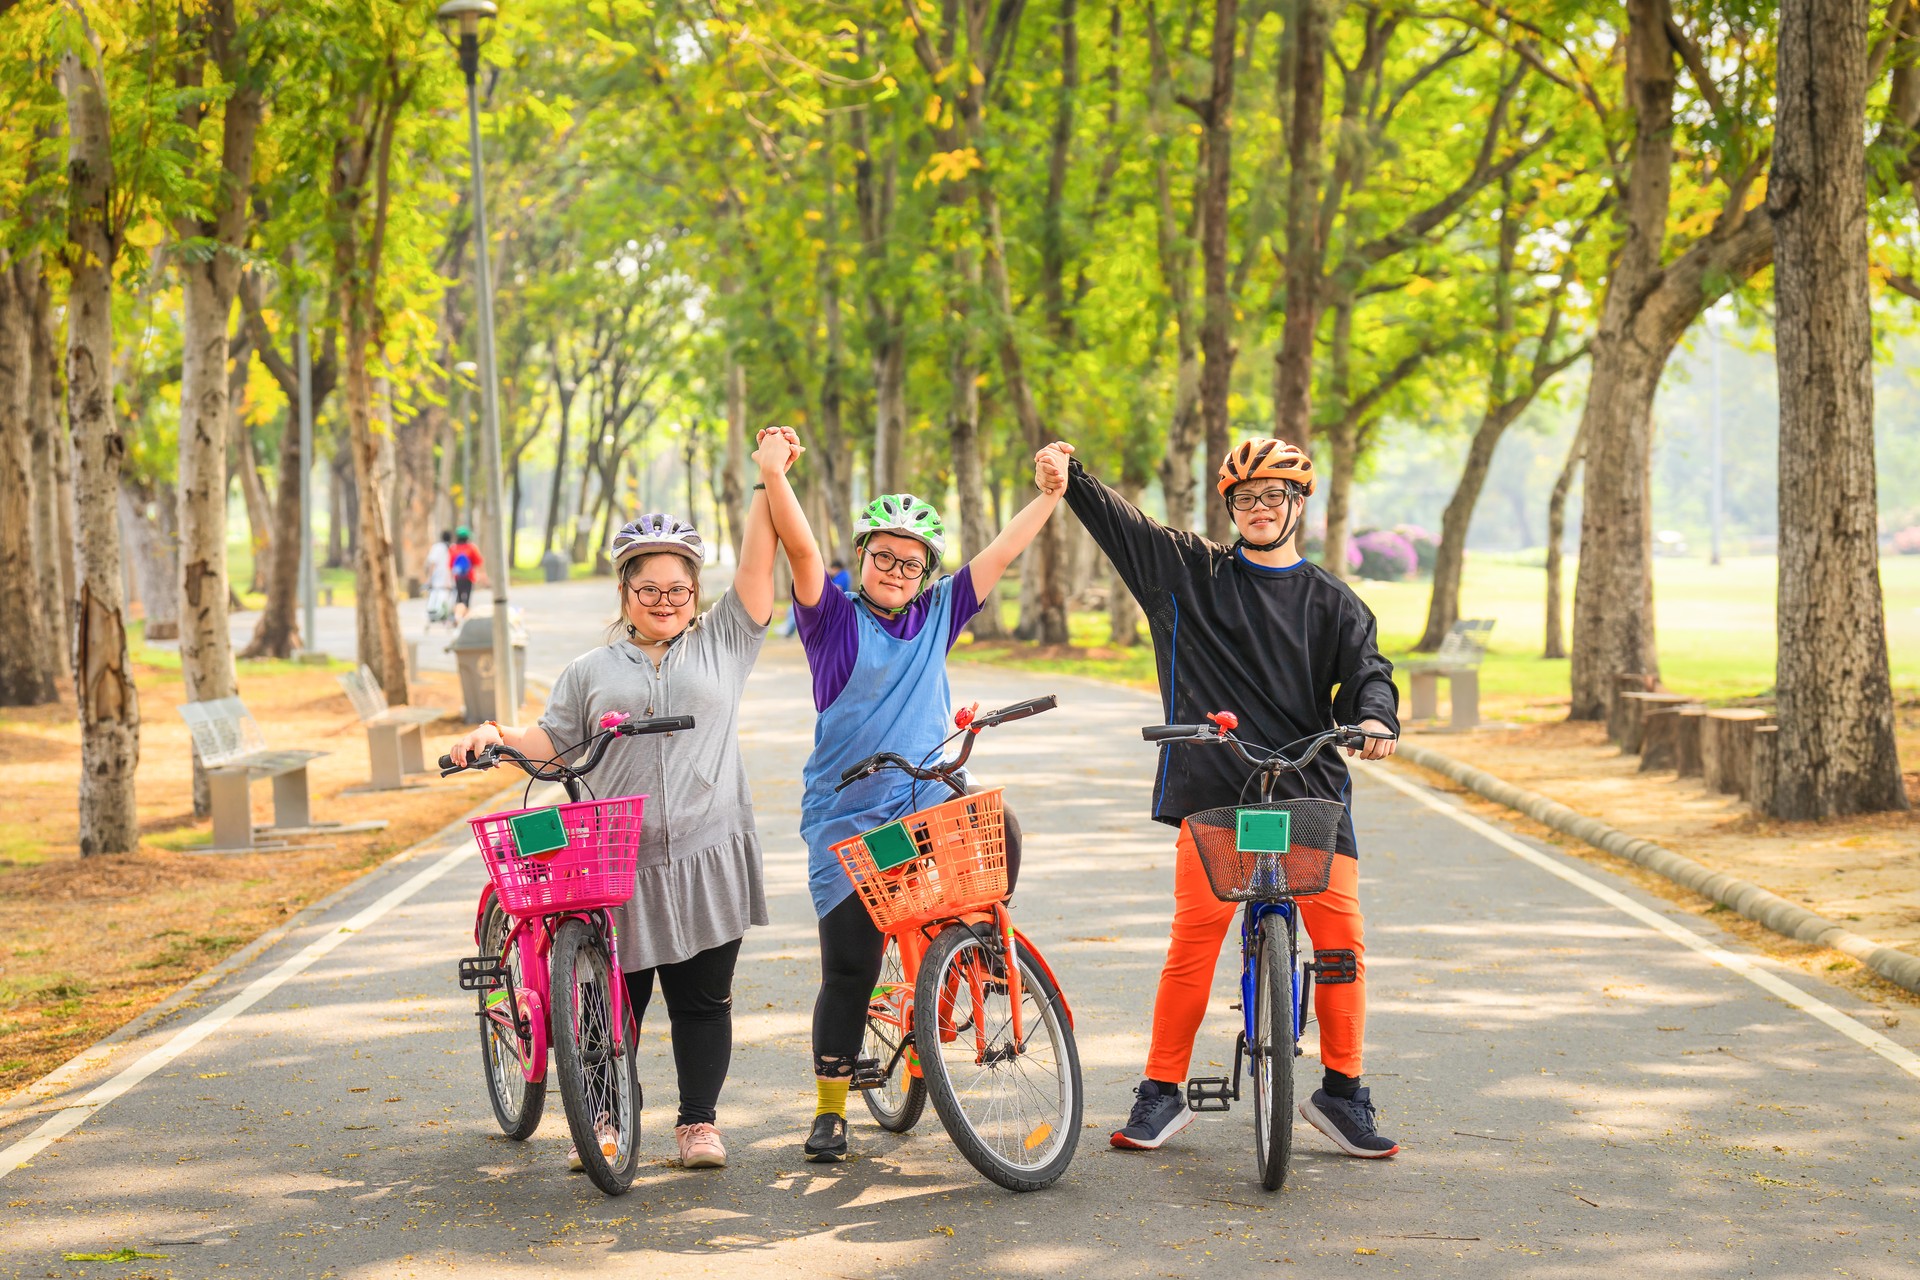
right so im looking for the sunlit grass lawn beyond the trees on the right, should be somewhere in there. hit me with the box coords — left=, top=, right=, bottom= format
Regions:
left=962, top=555, right=1920, bottom=720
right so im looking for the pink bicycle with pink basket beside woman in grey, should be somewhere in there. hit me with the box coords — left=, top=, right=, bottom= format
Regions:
left=440, top=712, right=693, bottom=1196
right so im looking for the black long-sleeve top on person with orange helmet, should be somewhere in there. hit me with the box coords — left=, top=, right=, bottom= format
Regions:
left=1068, top=459, right=1400, bottom=840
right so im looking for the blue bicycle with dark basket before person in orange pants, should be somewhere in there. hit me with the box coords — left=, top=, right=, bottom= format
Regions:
left=1140, top=712, right=1392, bottom=1192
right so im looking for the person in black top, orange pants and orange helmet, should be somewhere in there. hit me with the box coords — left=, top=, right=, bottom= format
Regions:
left=1035, top=439, right=1400, bottom=1159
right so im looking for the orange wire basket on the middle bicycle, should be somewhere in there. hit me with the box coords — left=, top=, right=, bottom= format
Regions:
left=833, top=787, right=1006, bottom=933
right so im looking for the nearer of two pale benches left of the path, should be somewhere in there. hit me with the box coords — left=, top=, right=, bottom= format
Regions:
left=180, top=697, right=386, bottom=854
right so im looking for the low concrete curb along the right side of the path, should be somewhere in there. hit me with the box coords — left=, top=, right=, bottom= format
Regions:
left=1394, top=741, right=1920, bottom=994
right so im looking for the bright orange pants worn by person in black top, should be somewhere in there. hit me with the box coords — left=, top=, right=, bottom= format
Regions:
left=1146, top=823, right=1367, bottom=1084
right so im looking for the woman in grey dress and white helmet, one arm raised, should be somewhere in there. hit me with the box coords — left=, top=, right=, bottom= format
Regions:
left=449, top=445, right=774, bottom=1169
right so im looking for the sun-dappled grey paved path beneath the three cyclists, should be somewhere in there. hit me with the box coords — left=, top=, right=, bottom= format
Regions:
left=0, top=585, right=1920, bottom=1280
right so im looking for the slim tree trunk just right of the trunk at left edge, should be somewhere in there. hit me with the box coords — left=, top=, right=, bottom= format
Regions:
left=27, top=257, right=73, bottom=681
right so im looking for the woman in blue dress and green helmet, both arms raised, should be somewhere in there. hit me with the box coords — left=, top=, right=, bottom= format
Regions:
left=760, top=428, right=1066, bottom=1163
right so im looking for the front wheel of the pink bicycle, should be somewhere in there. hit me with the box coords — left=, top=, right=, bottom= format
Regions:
left=553, top=919, right=641, bottom=1196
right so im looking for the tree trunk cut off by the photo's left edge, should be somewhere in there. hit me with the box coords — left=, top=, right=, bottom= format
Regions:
left=0, top=249, right=58, bottom=706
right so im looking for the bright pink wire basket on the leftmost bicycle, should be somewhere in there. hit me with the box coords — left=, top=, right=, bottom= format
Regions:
left=472, top=796, right=647, bottom=917
